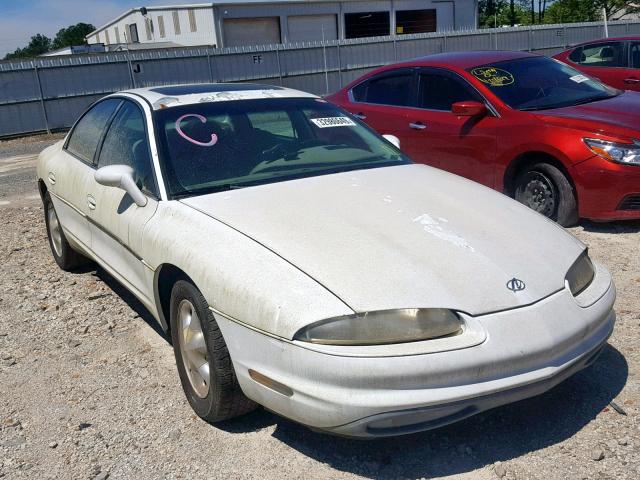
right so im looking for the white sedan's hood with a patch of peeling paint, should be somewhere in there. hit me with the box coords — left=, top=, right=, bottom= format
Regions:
left=182, top=165, right=584, bottom=315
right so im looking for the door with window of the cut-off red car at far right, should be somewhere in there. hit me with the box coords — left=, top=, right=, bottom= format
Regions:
left=568, top=41, right=633, bottom=90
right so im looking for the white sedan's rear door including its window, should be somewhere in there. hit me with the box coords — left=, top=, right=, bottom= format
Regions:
left=45, top=98, right=120, bottom=250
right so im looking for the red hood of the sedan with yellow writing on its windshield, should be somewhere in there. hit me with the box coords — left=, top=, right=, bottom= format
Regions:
left=537, top=92, right=640, bottom=138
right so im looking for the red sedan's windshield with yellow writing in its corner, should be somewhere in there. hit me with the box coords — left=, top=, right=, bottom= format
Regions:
left=468, top=57, right=620, bottom=110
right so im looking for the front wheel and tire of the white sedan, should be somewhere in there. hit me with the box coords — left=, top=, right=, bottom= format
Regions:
left=170, top=280, right=257, bottom=423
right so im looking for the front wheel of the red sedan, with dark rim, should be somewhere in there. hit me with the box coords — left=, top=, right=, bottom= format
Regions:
left=514, top=163, right=578, bottom=227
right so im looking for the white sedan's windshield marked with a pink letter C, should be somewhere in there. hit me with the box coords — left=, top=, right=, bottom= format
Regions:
left=155, top=98, right=410, bottom=198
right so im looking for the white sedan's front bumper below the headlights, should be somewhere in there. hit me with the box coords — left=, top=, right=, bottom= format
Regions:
left=216, top=267, right=615, bottom=437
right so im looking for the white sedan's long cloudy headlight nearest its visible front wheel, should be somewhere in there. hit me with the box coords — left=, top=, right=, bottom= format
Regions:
left=294, top=308, right=463, bottom=345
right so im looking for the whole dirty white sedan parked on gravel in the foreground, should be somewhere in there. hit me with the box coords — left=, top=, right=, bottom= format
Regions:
left=38, top=84, right=615, bottom=437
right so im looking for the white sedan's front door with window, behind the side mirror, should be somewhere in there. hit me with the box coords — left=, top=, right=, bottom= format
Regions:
left=88, top=99, right=159, bottom=301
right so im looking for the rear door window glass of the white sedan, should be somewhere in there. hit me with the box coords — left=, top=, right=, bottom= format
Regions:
left=66, top=98, right=122, bottom=163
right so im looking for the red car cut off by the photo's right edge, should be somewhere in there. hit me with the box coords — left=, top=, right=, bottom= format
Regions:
left=554, top=37, right=640, bottom=91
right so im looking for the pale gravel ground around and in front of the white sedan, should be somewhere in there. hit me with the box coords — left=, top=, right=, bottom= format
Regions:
left=0, top=137, right=640, bottom=480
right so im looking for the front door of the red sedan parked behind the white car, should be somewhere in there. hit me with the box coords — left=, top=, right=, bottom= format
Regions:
left=403, top=68, right=499, bottom=187
